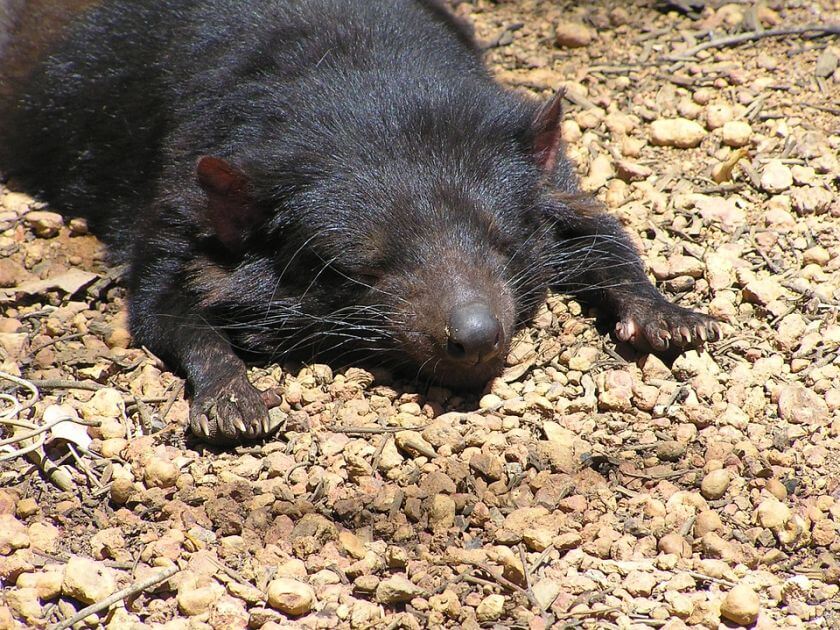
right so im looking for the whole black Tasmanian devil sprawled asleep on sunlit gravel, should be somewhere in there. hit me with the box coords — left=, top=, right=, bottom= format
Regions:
left=0, top=0, right=719, bottom=442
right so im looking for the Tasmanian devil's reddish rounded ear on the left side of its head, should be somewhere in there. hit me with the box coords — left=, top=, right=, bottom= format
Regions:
left=195, top=155, right=262, bottom=251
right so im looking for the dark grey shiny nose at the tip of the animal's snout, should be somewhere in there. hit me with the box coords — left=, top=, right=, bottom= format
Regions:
left=446, top=302, right=502, bottom=364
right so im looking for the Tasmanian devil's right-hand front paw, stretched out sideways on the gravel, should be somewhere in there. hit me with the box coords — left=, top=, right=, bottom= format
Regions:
left=615, top=299, right=721, bottom=352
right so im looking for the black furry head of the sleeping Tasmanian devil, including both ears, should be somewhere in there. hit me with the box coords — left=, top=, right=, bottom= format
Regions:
left=198, top=89, right=575, bottom=387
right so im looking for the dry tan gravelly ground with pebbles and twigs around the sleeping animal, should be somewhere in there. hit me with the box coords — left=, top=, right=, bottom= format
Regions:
left=0, top=0, right=840, bottom=630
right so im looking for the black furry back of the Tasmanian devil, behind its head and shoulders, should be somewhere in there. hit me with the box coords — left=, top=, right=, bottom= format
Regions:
left=0, top=0, right=484, bottom=257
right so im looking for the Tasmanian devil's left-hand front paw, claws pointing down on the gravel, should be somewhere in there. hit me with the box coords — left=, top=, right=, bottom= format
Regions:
left=190, top=375, right=277, bottom=444
